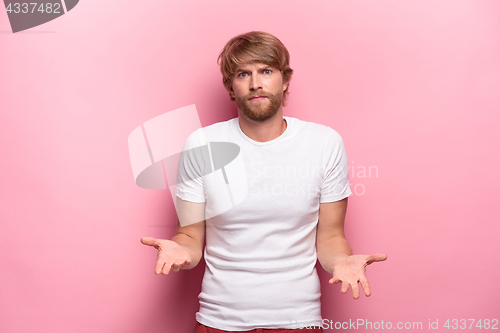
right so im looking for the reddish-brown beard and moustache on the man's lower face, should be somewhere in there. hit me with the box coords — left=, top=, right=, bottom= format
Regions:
left=236, top=92, right=283, bottom=122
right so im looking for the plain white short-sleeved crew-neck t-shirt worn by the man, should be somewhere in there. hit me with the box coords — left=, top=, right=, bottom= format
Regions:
left=176, top=116, right=351, bottom=331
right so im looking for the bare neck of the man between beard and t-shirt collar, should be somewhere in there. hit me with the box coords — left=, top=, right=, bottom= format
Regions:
left=238, top=108, right=287, bottom=142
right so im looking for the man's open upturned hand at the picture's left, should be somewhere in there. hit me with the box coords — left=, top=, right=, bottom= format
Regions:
left=141, top=237, right=191, bottom=275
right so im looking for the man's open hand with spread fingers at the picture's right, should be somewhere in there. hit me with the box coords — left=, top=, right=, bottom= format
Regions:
left=328, top=253, right=387, bottom=299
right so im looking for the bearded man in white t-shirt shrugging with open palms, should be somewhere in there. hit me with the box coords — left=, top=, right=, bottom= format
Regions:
left=141, top=31, right=387, bottom=333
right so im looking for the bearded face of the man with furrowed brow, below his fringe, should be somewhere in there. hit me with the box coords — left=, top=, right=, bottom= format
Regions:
left=230, top=63, right=288, bottom=121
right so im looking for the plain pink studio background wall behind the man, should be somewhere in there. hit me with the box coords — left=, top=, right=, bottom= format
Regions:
left=0, top=0, right=500, bottom=333
